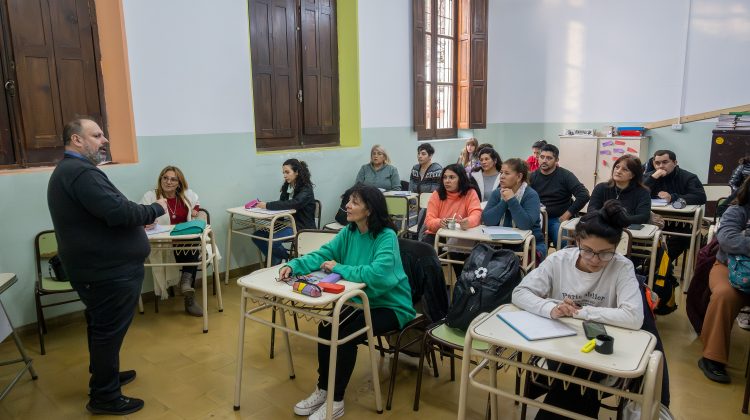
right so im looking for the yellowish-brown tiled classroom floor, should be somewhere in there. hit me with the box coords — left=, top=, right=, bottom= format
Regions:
left=0, top=282, right=750, bottom=420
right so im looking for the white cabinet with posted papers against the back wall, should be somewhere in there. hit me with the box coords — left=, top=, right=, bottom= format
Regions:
left=560, top=136, right=648, bottom=192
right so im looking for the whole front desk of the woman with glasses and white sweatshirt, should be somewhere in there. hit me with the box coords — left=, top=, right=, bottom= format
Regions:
left=458, top=304, right=662, bottom=420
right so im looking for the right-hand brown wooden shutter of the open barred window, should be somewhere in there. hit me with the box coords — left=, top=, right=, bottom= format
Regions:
left=469, top=0, right=487, bottom=128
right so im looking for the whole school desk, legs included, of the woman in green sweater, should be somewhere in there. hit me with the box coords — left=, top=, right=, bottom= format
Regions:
left=234, top=265, right=383, bottom=419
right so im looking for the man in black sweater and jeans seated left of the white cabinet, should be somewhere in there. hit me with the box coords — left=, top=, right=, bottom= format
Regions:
left=529, top=144, right=590, bottom=246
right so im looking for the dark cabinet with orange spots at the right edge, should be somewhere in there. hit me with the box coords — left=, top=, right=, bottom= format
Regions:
left=708, top=130, right=750, bottom=185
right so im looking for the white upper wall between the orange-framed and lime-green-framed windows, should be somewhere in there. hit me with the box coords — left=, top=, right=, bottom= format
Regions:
left=123, top=0, right=255, bottom=136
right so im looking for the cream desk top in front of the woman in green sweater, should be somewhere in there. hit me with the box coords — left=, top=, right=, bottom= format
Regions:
left=237, top=265, right=365, bottom=306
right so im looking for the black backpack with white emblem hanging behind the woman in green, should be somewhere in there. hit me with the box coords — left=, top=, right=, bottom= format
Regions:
left=446, top=244, right=522, bottom=330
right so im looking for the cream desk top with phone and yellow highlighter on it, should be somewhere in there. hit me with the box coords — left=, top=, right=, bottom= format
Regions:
left=470, top=304, right=656, bottom=378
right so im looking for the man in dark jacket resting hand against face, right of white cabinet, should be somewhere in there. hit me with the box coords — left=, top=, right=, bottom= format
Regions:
left=643, top=150, right=706, bottom=261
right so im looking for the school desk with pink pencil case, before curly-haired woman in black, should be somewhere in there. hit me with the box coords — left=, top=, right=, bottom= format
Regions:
left=224, top=207, right=297, bottom=284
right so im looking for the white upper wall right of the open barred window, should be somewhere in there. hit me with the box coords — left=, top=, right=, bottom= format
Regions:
left=488, top=0, right=750, bottom=123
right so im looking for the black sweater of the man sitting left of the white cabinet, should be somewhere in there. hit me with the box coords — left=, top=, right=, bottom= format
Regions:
left=529, top=167, right=589, bottom=217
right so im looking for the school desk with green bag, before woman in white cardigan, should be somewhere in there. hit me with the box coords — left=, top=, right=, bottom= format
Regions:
left=143, top=225, right=224, bottom=333
